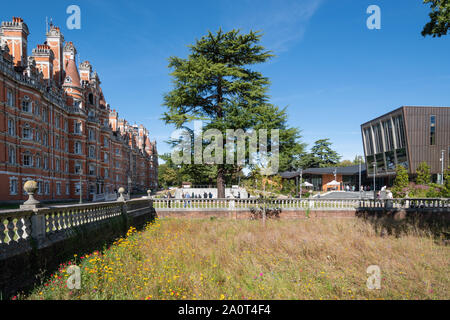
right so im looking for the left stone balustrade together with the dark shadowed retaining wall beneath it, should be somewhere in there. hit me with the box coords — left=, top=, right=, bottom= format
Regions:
left=0, top=181, right=156, bottom=297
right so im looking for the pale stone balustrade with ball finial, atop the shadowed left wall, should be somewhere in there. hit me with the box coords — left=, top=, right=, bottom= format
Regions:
left=0, top=184, right=153, bottom=259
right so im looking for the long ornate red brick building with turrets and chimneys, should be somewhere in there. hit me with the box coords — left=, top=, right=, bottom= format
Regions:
left=0, top=17, right=158, bottom=202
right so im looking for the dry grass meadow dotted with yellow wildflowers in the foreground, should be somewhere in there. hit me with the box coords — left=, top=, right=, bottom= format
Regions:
left=19, top=219, right=450, bottom=299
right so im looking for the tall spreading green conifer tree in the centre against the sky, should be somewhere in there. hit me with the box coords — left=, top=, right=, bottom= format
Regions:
left=162, top=30, right=305, bottom=197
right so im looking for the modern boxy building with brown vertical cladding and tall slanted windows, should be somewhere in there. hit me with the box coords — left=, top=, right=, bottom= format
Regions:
left=361, top=106, right=450, bottom=176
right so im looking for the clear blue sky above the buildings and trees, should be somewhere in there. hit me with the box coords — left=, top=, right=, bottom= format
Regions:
left=1, top=0, right=450, bottom=159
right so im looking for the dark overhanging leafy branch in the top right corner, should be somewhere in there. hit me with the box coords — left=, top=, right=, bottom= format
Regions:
left=422, top=0, right=450, bottom=38
